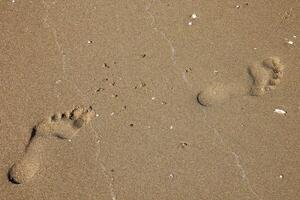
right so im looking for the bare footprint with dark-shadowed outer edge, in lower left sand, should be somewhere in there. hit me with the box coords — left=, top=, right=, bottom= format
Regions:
left=8, top=107, right=95, bottom=184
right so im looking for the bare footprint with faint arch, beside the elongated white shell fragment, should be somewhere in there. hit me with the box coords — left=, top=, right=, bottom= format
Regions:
left=197, top=57, right=285, bottom=106
